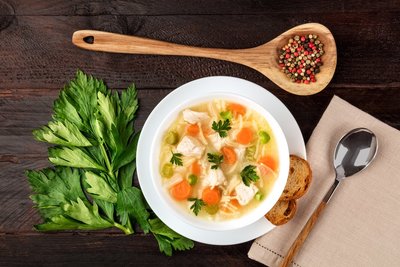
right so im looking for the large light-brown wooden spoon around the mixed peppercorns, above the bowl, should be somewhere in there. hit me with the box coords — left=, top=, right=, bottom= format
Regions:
left=72, top=23, right=337, bottom=95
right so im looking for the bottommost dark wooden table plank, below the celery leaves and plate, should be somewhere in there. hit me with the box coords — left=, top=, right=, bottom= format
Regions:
left=0, top=236, right=263, bottom=267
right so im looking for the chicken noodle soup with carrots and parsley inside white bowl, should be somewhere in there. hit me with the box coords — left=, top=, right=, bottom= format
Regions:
left=160, top=99, right=279, bottom=221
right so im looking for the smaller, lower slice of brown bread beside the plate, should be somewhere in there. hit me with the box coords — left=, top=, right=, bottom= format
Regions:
left=265, top=200, right=297, bottom=225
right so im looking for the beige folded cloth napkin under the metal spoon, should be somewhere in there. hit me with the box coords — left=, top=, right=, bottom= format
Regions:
left=248, top=96, right=400, bottom=267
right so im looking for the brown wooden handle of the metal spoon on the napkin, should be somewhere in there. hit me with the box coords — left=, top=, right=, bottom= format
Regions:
left=281, top=201, right=326, bottom=267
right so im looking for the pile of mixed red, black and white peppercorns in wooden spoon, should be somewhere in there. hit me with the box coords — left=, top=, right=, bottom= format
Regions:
left=279, top=34, right=324, bottom=84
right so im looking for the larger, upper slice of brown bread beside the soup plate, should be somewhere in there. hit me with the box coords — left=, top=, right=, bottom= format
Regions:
left=279, top=155, right=312, bottom=200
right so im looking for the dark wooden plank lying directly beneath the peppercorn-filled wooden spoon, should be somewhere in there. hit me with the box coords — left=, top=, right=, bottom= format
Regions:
left=0, top=12, right=400, bottom=90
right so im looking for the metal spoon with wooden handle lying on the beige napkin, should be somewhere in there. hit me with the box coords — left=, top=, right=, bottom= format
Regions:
left=281, top=128, right=378, bottom=267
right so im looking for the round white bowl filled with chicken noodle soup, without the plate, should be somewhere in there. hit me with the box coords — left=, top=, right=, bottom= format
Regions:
left=150, top=94, right=289, bottom=230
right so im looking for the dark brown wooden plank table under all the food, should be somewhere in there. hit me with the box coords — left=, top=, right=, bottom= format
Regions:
left=0, top=0, right=400, bottom=266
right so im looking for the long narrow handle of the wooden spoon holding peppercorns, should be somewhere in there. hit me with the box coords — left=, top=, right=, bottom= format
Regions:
left=72, top=30, right=240, bottom=63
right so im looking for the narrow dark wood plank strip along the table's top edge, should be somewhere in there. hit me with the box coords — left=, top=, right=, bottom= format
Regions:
left=3, top=0, right=400, bottom=16
